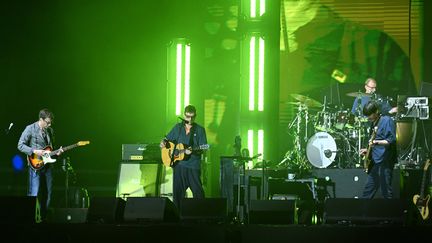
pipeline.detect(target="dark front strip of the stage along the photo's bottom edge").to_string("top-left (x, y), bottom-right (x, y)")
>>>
top-left (0, 222), bottom-right (432, 243)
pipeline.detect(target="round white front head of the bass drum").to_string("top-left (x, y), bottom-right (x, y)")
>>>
top-left (306, 132), bottom-right (337, 168)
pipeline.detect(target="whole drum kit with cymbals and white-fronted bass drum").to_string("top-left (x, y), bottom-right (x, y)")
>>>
top-left (283, 92), bottom-right (369, 168)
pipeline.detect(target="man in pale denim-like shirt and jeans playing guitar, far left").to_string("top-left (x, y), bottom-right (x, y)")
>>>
top-left (18, 109), bottom-right (63, 220)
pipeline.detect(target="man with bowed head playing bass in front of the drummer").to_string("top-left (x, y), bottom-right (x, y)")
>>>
top-left (360, 101), bottom-right (397, 199)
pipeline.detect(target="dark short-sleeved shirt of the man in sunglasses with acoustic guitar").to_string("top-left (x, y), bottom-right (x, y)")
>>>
top-left (166, 123), bottom-right (207, 169)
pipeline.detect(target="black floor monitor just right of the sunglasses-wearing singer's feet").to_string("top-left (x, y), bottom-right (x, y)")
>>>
top-left (180, 198), bottom-right (228, 223)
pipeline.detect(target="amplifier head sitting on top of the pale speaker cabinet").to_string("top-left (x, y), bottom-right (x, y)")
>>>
top-left (122, 143), bottom-right (160, 161)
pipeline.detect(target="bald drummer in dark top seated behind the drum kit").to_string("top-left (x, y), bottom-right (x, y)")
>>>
top-left (351, 78), bottom-right (397, 117)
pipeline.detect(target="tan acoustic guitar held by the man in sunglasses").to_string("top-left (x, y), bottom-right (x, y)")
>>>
top-left (161, 141), bottom-right (210, 167)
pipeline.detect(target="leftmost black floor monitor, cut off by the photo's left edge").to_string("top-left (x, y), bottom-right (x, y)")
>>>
top-left (0, 196), bottom-right (41, 224)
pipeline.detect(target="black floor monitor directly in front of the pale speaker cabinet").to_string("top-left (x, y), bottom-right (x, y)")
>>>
top-left (124, 197), bottom-right (179, 223)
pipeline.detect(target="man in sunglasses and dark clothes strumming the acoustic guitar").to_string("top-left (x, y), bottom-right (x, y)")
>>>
top-left (160, 105), bottom-right (207, 207)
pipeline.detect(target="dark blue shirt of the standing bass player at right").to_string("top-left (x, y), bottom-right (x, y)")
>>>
top-left (371, 116), bottom-right (396, 164)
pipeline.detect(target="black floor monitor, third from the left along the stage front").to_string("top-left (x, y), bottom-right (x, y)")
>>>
top-left (87, 197), bottom-right (126, 223)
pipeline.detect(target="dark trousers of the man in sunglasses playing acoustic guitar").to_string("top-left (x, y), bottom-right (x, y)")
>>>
top-left (173, 164), bottom-right (204, 208)
